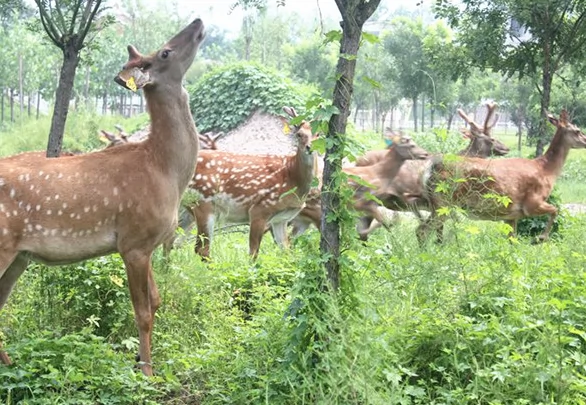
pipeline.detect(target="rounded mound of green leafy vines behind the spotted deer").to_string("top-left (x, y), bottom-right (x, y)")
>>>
top-left (189, 63), bottom-right (314, 132)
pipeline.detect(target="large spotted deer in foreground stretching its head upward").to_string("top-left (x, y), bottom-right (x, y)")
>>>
top-left (0, 19), bottom-right (204, 375)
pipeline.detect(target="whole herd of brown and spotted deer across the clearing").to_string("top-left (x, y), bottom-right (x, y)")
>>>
top-left (0, 19), bottom-right (586, 375)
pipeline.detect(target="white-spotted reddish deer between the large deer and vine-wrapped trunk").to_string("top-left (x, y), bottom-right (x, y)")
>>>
top-left (186, 107), bottom-right (317, 259)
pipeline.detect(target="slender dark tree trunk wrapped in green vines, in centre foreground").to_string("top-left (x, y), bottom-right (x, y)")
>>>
top-left (319, 0), bottom-right (380, 291)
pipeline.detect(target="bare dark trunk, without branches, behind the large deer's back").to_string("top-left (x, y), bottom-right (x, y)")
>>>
top-left (47, 43), bottom-right (79, 157)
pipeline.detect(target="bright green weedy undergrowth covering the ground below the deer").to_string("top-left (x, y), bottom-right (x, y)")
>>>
top-left (0, 213), bottom-right (586, 405)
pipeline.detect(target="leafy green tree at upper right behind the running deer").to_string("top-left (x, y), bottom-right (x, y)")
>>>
top-left (436, 0), bottom-right (586, 156)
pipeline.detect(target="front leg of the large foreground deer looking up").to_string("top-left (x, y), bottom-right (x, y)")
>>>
top-left (120, 249), bottom-right (155, 376)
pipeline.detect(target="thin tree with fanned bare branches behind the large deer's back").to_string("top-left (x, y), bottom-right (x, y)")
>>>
top-left (35, 0), bottom-right (111, 157)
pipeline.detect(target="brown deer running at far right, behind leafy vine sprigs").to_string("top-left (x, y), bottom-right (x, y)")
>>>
top-left (417, 110), bottom-right (586, 242)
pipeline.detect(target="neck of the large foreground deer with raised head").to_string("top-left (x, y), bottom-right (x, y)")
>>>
top-left (145, 86), bottom-right (199, 190)
